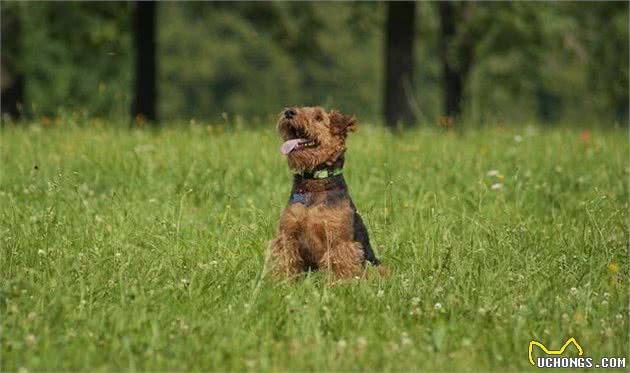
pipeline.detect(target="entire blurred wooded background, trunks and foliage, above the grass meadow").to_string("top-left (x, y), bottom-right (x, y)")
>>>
top-left (0, 1), bottom-right (629, 126)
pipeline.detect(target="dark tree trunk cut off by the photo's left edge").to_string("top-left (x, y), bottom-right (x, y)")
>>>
top-left (0, 4), bottom-right (24, 120)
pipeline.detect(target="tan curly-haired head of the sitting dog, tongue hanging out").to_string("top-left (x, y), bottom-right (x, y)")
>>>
top-left (277, 106), bottom-right (357, 171)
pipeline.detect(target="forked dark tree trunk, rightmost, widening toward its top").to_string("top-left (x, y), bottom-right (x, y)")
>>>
top-left (438, 1), bottom-right (474, 117)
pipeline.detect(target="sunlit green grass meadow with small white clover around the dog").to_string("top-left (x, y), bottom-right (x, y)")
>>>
top-left (0, 122), bottom-right (630, 371)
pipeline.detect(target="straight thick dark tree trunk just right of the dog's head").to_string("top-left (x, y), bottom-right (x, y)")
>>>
top-left (384, 2), bottom-right (416, 128)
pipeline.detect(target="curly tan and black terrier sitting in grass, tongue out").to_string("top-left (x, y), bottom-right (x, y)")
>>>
top-left (268, 107), bottom-right (383, 279)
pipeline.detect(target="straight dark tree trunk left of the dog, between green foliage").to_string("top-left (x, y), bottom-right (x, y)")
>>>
top-left (131, 1), bottom-right (157, 122)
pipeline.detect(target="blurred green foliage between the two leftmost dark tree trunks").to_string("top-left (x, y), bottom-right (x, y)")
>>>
top-left (17, 2), bottom-right (132, 117)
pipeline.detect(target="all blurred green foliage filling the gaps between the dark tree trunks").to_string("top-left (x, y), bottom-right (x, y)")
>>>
top-left (2, 2), bottom-right (629, 123)
